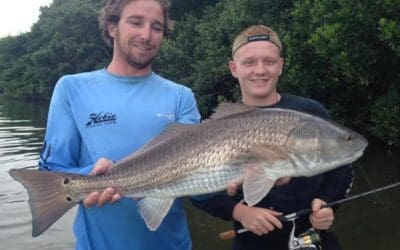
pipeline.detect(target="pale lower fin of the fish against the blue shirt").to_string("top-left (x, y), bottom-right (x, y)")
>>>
top-left (139, 198), bottom-right (174, 231)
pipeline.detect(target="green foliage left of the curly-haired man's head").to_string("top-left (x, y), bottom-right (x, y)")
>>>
top-left (0, 0), bottom-right (110, 100)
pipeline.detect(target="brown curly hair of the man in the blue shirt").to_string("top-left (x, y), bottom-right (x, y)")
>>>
top-left (99, 0), bottom-right (173, 47)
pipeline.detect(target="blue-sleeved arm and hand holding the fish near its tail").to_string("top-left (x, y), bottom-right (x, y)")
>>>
top-left (39, 79), bottom-right (121, 207)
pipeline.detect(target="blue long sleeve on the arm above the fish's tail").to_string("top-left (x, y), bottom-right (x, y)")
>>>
top-left (39, 78), bottom-right (93, 175)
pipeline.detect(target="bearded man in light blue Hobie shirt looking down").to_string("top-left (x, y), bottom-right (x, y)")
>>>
top-left (40, 0), bottom-right (200, 250)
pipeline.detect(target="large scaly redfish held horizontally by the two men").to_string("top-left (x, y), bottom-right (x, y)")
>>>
top-left (10, 103), bottom-right (367, 236)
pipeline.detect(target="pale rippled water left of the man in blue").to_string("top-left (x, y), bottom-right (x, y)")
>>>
top-left (0, 99), bottom-right (74, 249)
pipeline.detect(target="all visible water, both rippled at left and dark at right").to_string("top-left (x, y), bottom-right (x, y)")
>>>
top-left (0, 99), bottom-right (400, 250)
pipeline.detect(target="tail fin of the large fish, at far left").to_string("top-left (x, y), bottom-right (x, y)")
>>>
top-left (9, 169), bottom-right (78, 237)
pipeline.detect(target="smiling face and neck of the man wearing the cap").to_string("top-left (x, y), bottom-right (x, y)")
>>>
top-left (229, 41), bottom-right (283, 105)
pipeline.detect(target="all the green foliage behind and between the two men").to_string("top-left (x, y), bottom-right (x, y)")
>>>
top-left (0, 0), bottom-right (400, 146)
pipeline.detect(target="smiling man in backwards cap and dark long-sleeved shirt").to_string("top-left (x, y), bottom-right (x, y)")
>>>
top-left (193, 25), bottom-right (353, 250)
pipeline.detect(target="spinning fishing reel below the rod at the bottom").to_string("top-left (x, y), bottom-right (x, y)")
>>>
top-left (288, 220), bottom-right (321, 250)
